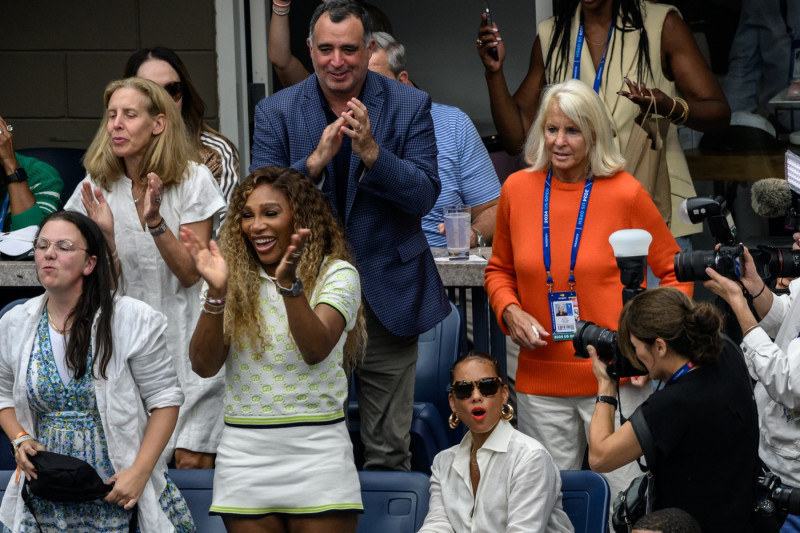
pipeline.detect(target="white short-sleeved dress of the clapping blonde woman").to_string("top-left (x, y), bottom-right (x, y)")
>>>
top-left (64, 162), bottom-right (225, 453)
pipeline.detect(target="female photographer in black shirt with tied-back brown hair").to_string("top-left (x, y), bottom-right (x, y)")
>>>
top-left (588, 288), bottom-right (758, 533)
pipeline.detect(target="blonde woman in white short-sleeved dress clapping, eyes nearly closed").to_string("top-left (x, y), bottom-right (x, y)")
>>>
top-left (65, 78), bottom-right (225, 468)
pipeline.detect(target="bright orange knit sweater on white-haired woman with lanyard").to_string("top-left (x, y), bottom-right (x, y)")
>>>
top-left (485, 170), bottom-right (693, 396)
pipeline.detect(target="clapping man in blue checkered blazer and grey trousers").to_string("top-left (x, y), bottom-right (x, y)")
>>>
top-left (250, 0), bottom-right (450, 470)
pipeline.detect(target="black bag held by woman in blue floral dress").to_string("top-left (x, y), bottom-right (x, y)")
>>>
top-left (22, 450), bottom-right (139, 533)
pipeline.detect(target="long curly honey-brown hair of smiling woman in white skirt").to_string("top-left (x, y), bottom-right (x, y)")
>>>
top-left (219, 167), bottom-right (366, 372)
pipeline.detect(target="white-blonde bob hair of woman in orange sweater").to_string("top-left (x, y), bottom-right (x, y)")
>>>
top-left (524, 80), bottom-right (625, 178)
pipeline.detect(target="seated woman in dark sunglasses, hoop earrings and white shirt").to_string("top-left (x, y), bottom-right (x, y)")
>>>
top-left (420, 352), bottom-right (573, 533)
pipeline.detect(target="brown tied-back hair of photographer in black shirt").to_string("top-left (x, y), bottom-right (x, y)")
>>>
top-left (617, 287), bottom-right (724, 370)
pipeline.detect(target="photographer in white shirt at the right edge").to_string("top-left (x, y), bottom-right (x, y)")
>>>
top-left (704, 233), bottom-right (800, 532)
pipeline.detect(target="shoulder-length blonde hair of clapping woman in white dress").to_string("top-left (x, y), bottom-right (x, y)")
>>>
top-left (83, 78), bottom-right (200, 191)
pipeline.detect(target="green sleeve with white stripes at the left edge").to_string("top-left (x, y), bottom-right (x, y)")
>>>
top-left (10, 154), bottom-right (64, 231)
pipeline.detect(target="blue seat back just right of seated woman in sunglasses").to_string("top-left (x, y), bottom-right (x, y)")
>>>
top-left (561, 470), bottom-right (611, 533)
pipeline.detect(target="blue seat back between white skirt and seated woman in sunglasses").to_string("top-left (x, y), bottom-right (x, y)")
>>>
top-left (358, 471), bottom-right (430, 533)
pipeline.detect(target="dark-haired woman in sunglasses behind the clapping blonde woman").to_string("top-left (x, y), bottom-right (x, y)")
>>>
top-left (124, 46), bottom-right (239, 203)
